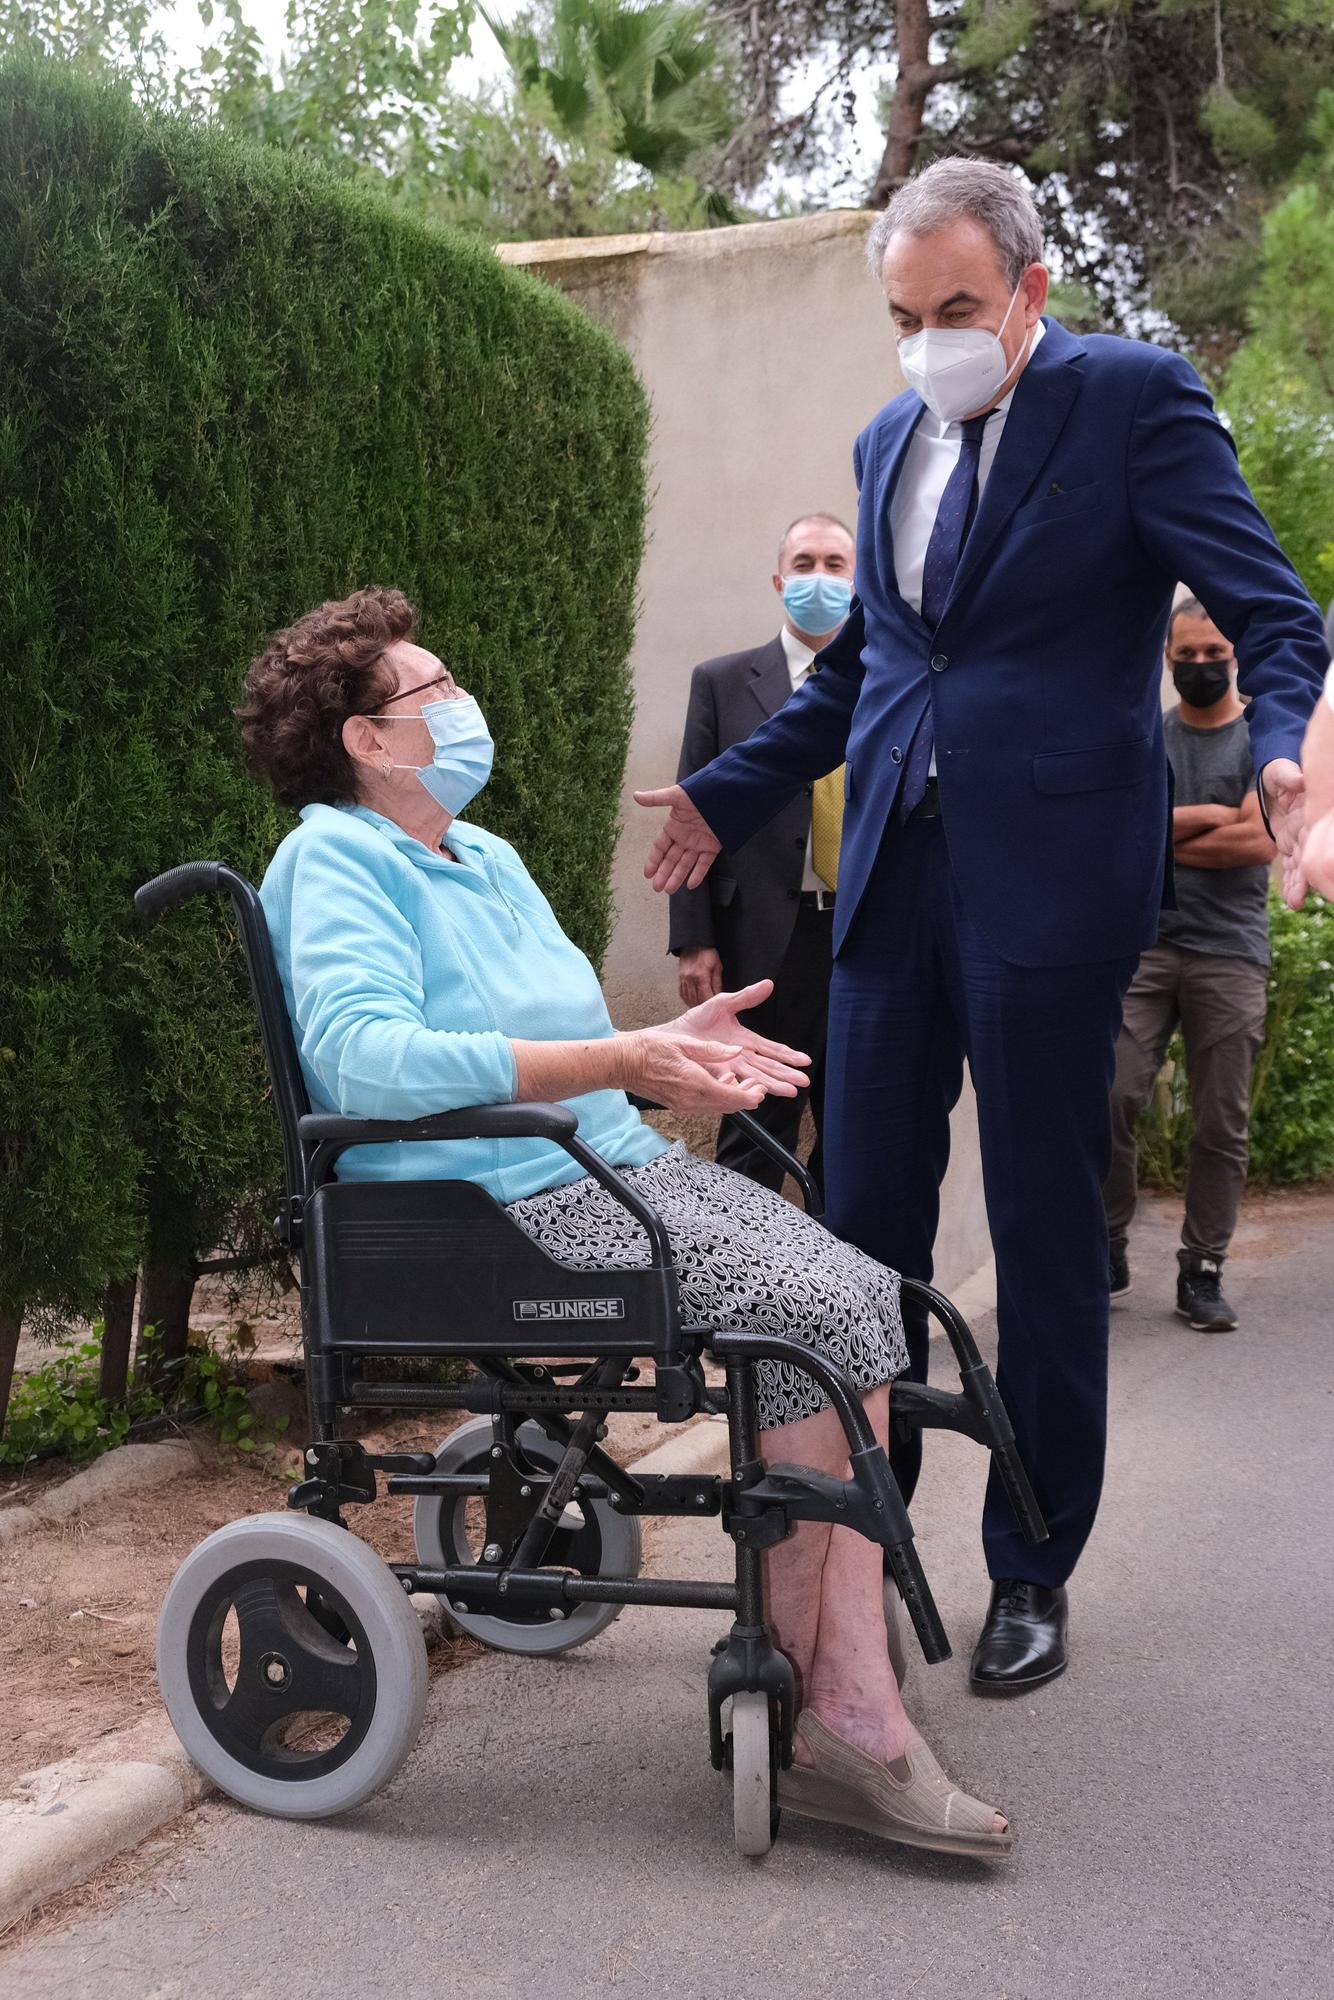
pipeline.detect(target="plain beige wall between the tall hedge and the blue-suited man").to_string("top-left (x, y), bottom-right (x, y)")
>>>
top-left (500, 212), bottom-right (990, 1302)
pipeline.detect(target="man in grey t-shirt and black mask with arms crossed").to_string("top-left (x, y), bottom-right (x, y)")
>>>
top-left (1104, 598), bottom-right (1274, 1334)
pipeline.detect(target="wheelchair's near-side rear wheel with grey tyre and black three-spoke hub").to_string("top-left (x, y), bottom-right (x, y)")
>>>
top-left (158, 1514), bottom-right (426, 1820)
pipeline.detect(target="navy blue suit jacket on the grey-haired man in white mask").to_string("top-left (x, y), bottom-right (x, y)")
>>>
top-left (686, 320), bottom-right (1326, 966)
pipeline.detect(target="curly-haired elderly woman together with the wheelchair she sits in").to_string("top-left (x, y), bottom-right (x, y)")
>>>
top-left (140, 590), bottom-right (1042, 1858)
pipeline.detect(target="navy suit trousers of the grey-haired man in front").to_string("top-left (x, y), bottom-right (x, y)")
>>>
top-left (824, 818), bottom-right (1134, 1584)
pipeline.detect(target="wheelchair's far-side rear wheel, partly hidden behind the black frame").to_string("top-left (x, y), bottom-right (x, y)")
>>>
top-left (412, 1416), bottom-right (642, 1654)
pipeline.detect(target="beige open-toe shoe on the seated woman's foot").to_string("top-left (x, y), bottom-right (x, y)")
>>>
top-left (778, 1708), bottom-right (1014, 1862)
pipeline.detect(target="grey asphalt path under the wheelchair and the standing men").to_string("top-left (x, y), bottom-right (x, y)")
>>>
top-left (0, 1196), bottom-right (1334, 2000)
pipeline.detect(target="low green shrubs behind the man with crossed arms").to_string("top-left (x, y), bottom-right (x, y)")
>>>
top-left (1138, 890), bottom-right (1334, 1188)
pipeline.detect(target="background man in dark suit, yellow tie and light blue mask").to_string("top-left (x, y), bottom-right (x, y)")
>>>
top-left (668, 514), bottom-right (852, 1190)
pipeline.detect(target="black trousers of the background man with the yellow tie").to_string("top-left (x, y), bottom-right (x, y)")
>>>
top-left (714, 910), bottom-right (834, 1192)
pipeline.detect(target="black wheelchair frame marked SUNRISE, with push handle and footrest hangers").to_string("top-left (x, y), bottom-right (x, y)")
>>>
top-left (134, 862), bottom-right (1046, 1766)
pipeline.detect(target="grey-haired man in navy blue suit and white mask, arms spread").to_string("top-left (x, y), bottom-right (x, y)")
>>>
top-left (638, 160), bottom-right (1326, 1694)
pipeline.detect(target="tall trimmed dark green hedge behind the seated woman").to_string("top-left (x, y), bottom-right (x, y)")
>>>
top-left (0, 60), bottom-right (646, 1376)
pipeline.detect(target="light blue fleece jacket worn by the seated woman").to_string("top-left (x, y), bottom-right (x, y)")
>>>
top-left (260, 806), bottom-right (666, 1202)
